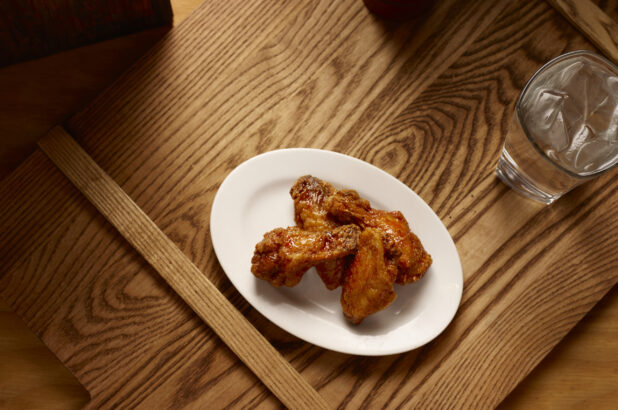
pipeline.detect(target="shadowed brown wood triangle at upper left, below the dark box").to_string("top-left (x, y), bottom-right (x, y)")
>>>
top-left (0, 28), bottom-right (169, 180)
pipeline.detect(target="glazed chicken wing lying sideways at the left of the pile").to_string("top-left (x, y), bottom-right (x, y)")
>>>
top-left (251, 225), bottom-right (360, 286)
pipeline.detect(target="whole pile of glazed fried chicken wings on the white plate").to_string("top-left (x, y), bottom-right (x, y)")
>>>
top-left (251, 175), bottom-right (432, 324)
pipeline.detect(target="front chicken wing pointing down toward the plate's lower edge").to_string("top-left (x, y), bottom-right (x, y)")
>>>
top-left (341, 228), bottom-right (397, 324)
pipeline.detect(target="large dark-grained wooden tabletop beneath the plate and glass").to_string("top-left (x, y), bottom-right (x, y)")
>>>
top-left (0, 1), bottom-right (617, 407)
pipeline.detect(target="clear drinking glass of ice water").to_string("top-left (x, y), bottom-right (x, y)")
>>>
top-left (496, 51), bottom-right (618, 204)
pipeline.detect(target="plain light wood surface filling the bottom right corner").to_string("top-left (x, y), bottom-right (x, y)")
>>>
top-left (500, 286), bottom-right (618, 410)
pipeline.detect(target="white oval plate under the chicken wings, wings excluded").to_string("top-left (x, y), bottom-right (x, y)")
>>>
top-left (210, 148), bottom-right (463, 356)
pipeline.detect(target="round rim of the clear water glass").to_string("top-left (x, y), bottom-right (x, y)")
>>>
top-left (515, 50), bottom-right (618, 179)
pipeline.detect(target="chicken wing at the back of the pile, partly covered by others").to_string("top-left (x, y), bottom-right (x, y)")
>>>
top-left (290, 175), bottom-right (350, 290)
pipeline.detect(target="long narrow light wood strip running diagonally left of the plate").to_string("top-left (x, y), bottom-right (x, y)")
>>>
top-left (39, 127), bottom-right (328, 409)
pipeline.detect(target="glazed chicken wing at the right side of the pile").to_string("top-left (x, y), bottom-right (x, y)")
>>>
top-left (324, 190), bottom-right (432, 284)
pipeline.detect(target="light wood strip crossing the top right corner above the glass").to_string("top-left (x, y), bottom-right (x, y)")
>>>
top-left (548, 0), bottom-right (618, 65)
